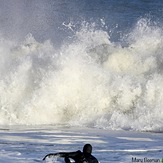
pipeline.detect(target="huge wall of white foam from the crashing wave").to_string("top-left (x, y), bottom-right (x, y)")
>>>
top-left (0, 19), bottom-right (163, 132)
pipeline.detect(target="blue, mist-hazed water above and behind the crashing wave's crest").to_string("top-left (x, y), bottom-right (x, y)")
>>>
top-left (0, 0), bottom-right (163, 45)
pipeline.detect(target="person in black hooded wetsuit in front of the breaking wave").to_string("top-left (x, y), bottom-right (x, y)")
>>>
top-left (43, 144), bottom-right (99, 163)
